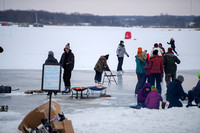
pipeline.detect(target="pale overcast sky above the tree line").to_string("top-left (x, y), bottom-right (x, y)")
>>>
top-left (0, 0), bottom-right (200, 16)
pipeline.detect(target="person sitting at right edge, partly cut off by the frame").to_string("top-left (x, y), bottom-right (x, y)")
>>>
top-left (186, 73), bottom-right (200, 108)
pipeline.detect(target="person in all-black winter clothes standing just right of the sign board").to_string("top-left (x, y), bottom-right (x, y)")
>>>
top-left (60, 43), bottom-right (74, 93)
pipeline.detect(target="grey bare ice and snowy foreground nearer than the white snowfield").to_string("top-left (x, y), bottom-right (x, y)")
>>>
top-left (0, 70), bottom-right (200, 133)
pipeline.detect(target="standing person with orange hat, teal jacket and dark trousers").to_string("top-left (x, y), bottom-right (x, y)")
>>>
top-left (135, 47), bottom-right (147, 94)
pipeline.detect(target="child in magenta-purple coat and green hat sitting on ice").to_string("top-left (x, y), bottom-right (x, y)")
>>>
top-left (145, 86), bottom-right (163, 109)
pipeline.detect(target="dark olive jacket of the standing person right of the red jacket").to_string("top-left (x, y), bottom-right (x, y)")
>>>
top-left (163, 52), bottom-right (181, 74)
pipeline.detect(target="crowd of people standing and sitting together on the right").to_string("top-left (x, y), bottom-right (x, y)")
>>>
top-left (135, 38), bottom-right (200, 109)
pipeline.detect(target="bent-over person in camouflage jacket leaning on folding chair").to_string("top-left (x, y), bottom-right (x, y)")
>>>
top-left (94, 54), bottom-right (110, 84)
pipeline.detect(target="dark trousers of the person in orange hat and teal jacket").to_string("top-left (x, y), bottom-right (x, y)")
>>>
top-left (135, 73), bottom-right (145, 94)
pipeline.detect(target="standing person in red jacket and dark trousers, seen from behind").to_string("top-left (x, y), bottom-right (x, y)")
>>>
top-left (145, 50), bottom-right (163, 94)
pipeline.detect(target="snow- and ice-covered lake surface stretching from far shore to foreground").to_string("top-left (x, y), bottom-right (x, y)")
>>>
top-left (0, 26), bottom-right (200, 133)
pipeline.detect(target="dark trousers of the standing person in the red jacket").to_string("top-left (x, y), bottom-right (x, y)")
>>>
top-left (150, 73), bottom-right (162, 94)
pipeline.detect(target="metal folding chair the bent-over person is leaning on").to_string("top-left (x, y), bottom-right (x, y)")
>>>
top-left (102, 70), bottom-right (117, 84)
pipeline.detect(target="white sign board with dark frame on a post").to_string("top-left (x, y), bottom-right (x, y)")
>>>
top-left (42, 64), bottom-right (61, 91)
